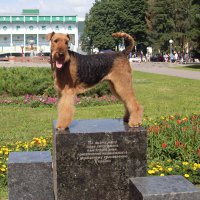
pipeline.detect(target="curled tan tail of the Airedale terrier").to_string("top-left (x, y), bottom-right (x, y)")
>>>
top-left (112, 32), bottom-right (135, 56)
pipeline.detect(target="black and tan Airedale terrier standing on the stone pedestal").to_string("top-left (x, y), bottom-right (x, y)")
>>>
top-left (47, 32), bottom-right (142, 130)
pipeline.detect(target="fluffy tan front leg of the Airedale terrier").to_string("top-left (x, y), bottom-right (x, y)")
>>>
top-left (56, 91), bottom-right (74, 130)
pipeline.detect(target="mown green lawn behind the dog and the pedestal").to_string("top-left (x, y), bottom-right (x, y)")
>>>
top-left (0, 72), bottom-right (200, 200)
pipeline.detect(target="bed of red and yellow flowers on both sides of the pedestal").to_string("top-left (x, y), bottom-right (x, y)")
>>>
top-left (0, 114), bottom-right (200, 184)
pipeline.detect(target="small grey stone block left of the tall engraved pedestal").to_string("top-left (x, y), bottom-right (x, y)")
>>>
top-left (8, 151), bottom-right (54, 200)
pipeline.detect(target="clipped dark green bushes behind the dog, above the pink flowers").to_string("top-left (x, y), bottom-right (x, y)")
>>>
top-left (0, 67), bottom-right (110, 96)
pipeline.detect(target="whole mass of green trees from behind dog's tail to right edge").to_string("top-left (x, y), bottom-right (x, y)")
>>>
top-left (82, 0), bottom-right (200, 55)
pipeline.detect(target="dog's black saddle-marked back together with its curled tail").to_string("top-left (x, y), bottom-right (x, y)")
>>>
top-left (69, 32), bottom-right (134, 85)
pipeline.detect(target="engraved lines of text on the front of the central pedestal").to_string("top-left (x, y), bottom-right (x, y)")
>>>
top-left (78, 140), bottom-right (128, 163)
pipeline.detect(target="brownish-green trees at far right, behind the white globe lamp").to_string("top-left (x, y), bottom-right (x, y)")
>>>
top-left (146, 0), bottom-right (200, 52)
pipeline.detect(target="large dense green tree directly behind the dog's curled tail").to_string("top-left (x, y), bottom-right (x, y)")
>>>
top-left (82, 0), bottom-right (147, 50)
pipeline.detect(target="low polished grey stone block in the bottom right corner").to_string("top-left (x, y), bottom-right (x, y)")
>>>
top-left (130, 175), bottom-right (200, 200)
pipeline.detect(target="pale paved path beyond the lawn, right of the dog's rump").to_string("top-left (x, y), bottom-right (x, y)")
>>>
top-left (131, 62), bottom-right (200, 80)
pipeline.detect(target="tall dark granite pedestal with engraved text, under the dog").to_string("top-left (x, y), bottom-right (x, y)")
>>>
top-left (53, 119), bottom-right (147, 200)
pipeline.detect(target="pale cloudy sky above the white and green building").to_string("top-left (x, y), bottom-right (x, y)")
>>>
top-left (0, 0), bottom-right (95, 18)
